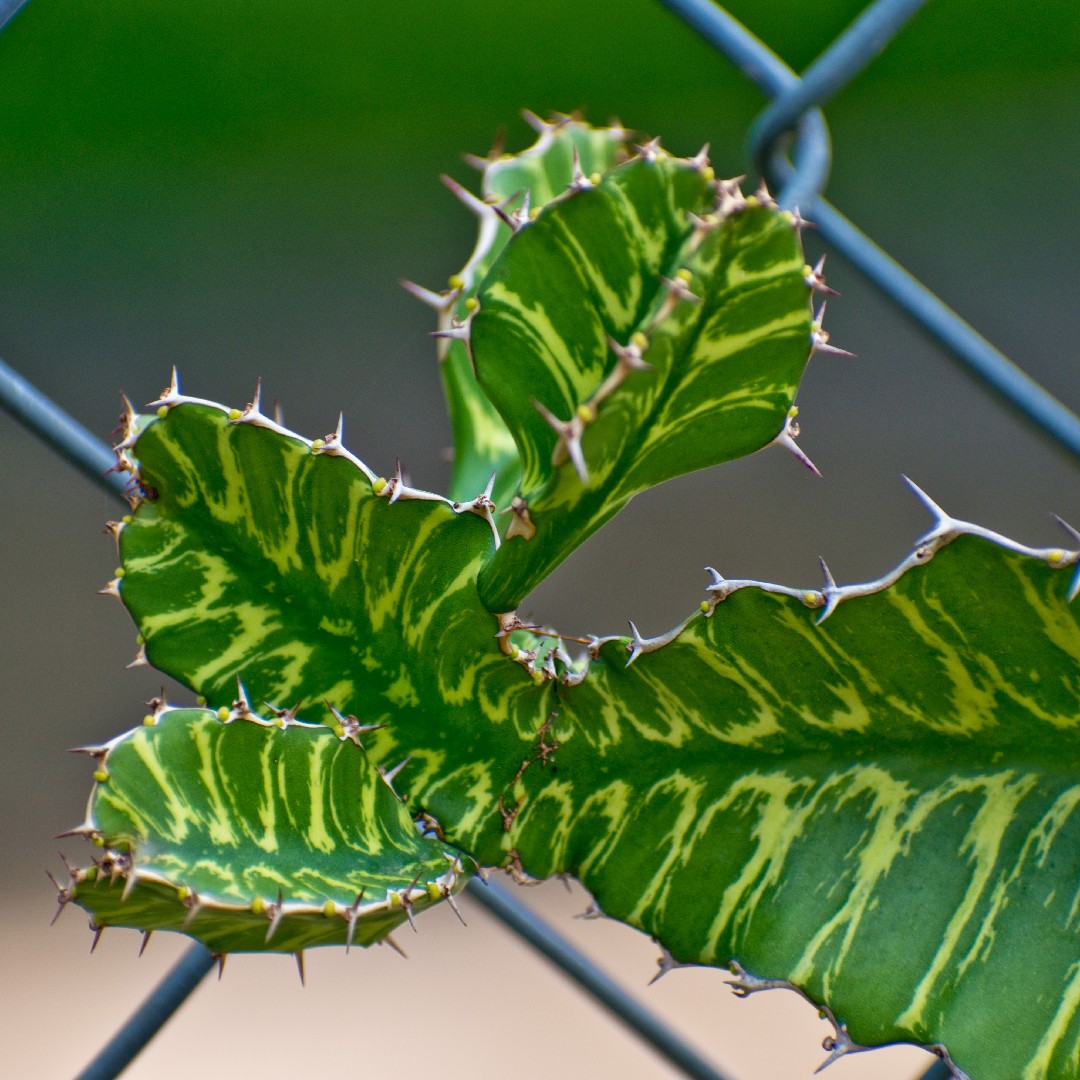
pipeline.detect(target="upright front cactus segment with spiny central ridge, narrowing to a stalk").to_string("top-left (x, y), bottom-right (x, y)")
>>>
top-left (470, 151), bottom-right (823, 611)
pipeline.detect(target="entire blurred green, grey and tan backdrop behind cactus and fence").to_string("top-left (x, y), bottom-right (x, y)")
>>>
top-left (0, 0), bottom-right (1080, 1080)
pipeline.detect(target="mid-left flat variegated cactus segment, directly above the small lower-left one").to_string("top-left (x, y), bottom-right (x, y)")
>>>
top-left (107, 388), bottom-right (554, 863)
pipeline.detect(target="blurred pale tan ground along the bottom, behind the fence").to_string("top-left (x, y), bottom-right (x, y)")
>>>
top-left (6, 875), bottom-right (931, 1080)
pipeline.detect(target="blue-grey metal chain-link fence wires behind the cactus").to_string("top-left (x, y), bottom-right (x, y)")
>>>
top-left (0, 0), bottom-right (1080, 1080)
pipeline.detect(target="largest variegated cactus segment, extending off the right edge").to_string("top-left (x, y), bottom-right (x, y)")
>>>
top-left (505, 531), bottom-right (1080, 1080)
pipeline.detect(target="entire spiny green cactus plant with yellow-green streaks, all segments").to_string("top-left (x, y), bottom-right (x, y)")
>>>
top-left (60, 113), bottom-right (1080, 1080)
